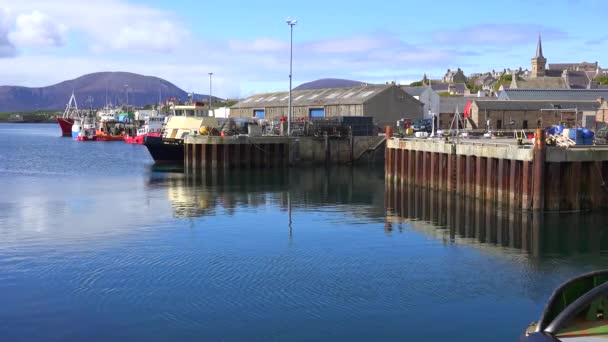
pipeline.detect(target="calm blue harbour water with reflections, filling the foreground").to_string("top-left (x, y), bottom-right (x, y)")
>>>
top-left (0, 124), bottom-right (608, 341)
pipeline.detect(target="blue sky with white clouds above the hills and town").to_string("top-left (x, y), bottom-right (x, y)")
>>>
top-left (0, 0), bottom-right (608, 98)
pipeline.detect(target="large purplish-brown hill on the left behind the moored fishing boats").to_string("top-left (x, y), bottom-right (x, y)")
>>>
top-left (0, 72), bottom-right (221, 113)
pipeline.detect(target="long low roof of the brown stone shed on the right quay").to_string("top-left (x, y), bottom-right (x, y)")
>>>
top-left (475, 100), bottom-right (600, 111)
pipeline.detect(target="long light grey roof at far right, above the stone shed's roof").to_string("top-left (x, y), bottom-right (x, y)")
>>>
top-left (498, 89), bottom-right (608, 101)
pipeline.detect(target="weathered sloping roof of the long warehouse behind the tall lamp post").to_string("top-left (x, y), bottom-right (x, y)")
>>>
top-left (231, 84), bottom-right (396, 108)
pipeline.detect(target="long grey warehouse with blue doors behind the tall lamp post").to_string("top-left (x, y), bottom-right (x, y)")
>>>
top-left (230, 84), bottom-right (424, 126)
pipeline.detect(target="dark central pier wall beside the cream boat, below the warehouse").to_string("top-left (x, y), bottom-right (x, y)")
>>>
top-left (184, 135), bottom-right (385, 172)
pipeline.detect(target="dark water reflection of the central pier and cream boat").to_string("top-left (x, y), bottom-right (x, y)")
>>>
top-left (157, 167), bottom-right (384, 218)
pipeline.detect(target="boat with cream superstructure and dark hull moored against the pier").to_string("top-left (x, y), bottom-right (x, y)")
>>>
top-left (144, 102), bottom-right (218, 164)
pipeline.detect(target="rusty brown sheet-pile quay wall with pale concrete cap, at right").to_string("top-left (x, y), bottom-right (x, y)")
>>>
top-left (385, 132), bottom-right (608, 211)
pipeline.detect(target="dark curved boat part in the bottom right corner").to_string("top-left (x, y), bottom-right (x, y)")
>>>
top-left (521, 270), bottom-right (608, 342)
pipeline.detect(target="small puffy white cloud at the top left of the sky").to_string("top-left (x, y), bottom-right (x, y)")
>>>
top-left (8, 11), bottom-right (66, 47)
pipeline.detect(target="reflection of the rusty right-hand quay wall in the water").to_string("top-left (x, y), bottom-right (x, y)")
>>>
top-left (385, 184), bottom-right (608, 257)
